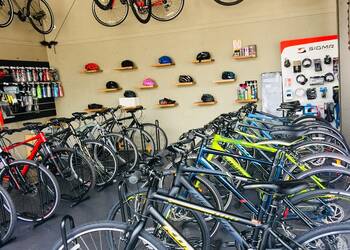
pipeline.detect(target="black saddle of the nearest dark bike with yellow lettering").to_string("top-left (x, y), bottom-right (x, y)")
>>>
top-left (243, 180), bottom-right (310, 196)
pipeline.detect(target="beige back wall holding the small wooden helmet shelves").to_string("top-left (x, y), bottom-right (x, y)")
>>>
top-left (43, 0), bottom-right (337, 140)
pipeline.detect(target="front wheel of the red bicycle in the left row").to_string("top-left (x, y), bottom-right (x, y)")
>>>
top-left (42, 148), bottom-right (96, 201)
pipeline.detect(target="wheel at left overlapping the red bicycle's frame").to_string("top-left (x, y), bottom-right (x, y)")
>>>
top-left (0, 160), bottom-right (61, 222)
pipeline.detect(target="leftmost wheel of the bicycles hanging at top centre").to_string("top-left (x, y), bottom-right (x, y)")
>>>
top-left (92, 0), bottom-right (129, 27)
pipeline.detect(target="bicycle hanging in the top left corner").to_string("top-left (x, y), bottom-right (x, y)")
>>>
top-left (0, 0), bottom-right (54, 35)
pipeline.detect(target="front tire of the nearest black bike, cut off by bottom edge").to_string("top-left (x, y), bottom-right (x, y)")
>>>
top-left (53, 221), bottom-right (166, 250)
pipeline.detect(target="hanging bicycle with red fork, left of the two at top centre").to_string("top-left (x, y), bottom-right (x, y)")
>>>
top-left (92, 0), bottom-right (152, 27)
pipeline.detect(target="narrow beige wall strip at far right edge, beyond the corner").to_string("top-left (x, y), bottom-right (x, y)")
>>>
top-left (338, 0), bottom-right (350, 139)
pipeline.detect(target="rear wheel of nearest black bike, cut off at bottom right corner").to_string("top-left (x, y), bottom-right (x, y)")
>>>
top-left (295, 223), bottom-right (350, 250)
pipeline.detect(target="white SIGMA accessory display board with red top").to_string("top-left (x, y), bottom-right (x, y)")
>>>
top-left (281, 35), bottom-right (339, 125)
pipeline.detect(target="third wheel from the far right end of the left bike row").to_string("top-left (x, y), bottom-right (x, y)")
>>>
top-left (100, 133), bottom-right (139, 171)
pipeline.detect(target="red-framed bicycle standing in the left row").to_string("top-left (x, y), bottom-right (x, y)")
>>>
top-left (5, 123), bottom-right (96, 204)
